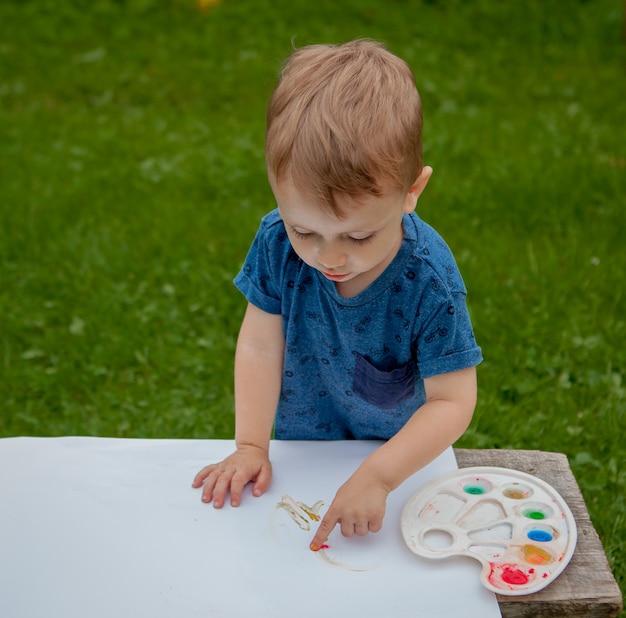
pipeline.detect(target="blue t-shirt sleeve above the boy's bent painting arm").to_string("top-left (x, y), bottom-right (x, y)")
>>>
top-left (417, 291), bottom-right (483, 379)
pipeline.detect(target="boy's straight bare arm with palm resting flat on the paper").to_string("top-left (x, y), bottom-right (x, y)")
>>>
top-left (193, 303), bottom-right (285, 508)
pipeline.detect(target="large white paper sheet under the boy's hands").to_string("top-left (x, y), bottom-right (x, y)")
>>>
top-left (0, 438), bottom-right (500, 618)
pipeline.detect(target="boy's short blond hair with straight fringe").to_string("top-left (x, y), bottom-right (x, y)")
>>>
top-left (265, 39), bottom-right (423, 214)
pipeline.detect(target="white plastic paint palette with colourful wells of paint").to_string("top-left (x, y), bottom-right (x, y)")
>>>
top-left (401, 467), bottom-right (577, 595)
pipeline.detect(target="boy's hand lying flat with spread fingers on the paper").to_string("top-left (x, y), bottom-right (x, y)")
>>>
top-left (192, 445), bottom-right (272, 509)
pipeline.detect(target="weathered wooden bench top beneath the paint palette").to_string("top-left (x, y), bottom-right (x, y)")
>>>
top-left (455, 449), bottom-right (622, 618)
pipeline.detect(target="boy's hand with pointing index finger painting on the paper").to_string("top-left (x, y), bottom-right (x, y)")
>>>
top-left (310, 470), bottom-right (389, 551)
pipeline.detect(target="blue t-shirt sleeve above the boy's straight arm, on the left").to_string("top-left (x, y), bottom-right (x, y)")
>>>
top-left (234, 216), bottom-right (283, 314)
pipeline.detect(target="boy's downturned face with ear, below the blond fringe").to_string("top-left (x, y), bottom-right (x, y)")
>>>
top-left (270, 168), bottom-right (432, 296)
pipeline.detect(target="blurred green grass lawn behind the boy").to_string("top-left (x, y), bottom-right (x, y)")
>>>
top-left (0, 0), bottom-right (626, 608)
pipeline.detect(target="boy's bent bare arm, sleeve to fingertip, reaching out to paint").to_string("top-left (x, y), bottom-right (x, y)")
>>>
top-left (311, 367), bottom-right (477, 551)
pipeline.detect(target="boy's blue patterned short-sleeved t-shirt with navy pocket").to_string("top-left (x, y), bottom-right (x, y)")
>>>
top-left (235, 210), bottom-right (482, 440)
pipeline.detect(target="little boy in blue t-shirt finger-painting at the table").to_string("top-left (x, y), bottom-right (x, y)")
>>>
top-left (193, 40), bottom-right (482, 551)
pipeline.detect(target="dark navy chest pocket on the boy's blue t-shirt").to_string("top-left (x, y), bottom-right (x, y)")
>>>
top-left (352, 354), bottom-right (415, 410)
